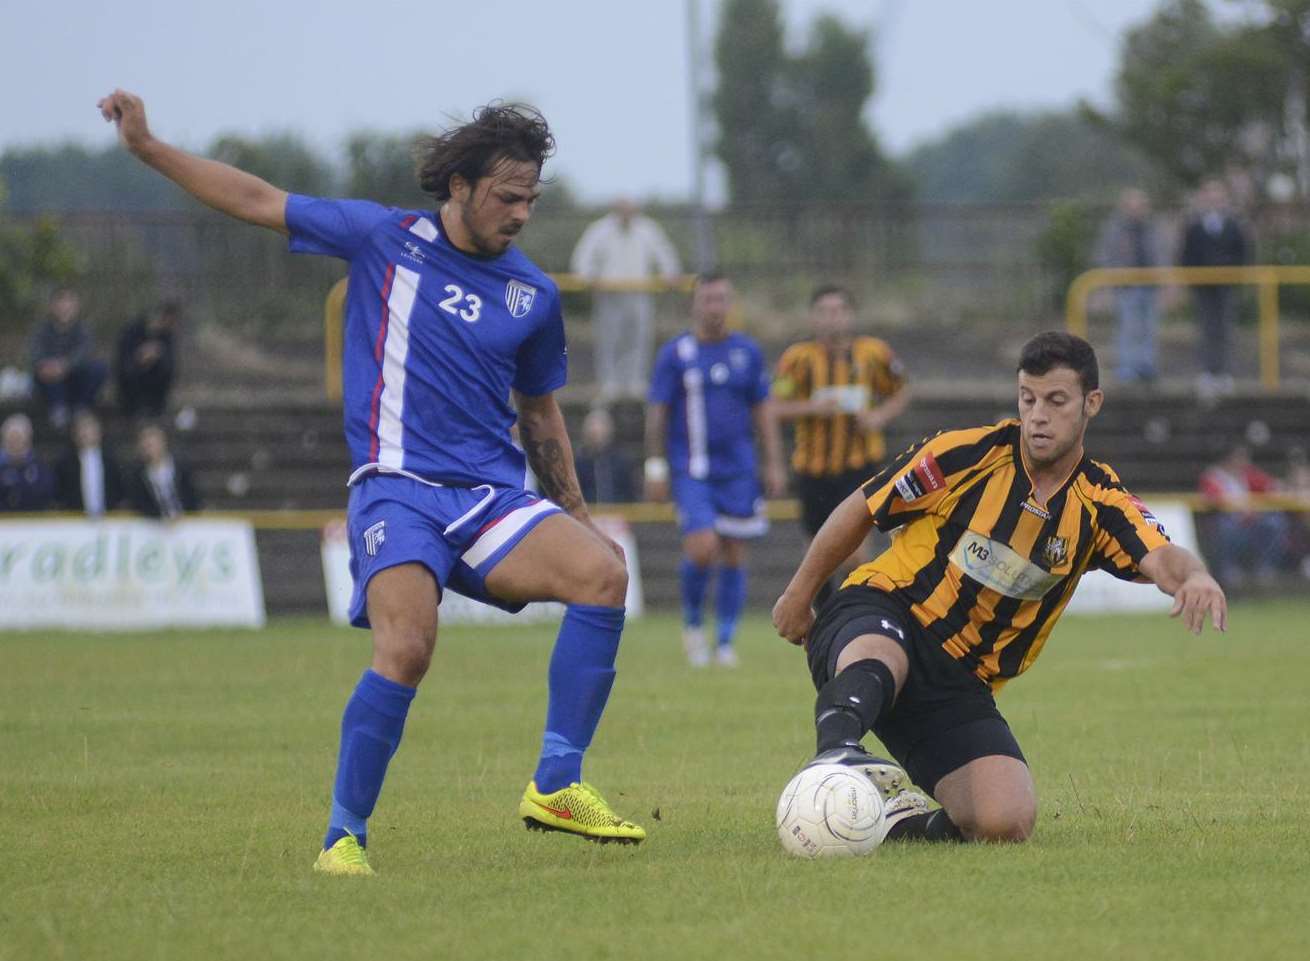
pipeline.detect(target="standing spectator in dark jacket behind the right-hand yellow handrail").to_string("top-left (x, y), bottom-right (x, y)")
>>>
top-left (1178, 178), bottom-right (1250, 397)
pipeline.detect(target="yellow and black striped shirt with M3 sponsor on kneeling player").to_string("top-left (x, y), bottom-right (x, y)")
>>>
top-left (844, 420), bottom-right (1169, 690)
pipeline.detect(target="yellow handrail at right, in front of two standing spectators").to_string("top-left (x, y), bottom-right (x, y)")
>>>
top-left (1065, 264), bottom-right (1310, 390)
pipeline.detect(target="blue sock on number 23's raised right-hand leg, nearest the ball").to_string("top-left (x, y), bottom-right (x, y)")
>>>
top-left (533, 604), bottom-right (624, 795)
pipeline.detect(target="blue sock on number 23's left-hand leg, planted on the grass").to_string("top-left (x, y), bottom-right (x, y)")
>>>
top-left (324, 670), bottom-right (414, 850)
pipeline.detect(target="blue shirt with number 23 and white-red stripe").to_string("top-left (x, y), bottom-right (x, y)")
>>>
top-left (287, 194), bottom-right (567, 487)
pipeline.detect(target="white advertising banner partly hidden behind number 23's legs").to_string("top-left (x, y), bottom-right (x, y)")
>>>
top-left (322, 516), bottom-right (643, 625)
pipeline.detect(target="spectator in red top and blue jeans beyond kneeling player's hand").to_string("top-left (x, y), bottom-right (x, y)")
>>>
top-left (1200, 444), bottom-right (1289, 585)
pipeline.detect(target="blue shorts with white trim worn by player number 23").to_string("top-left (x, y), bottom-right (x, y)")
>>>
top-left (346, 474), bottom-right (561, 627)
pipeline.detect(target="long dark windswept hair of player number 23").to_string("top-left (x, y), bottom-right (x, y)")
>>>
top-left (415, 103), bottom-right (555, 202)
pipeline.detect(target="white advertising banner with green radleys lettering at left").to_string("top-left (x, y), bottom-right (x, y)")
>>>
top-left (0, 518), bottom-right (265, 631)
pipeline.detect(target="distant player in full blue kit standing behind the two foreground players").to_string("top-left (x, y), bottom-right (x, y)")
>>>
top-left (646, 274), bottom-right (786, 666)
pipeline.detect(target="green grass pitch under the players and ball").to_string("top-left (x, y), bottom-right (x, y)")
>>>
top-left (0, 602), bottom-right (1310, 961)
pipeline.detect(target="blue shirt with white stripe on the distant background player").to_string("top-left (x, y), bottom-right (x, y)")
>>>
top-left (650, 331), bottom-right (769, 481)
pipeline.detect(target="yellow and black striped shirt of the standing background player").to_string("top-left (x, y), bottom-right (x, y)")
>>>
top-left (773, 336), bottom-right (905, 477)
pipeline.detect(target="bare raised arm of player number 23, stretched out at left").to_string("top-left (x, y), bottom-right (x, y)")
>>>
top-left (96, 90), bottom-right (287, 233)
